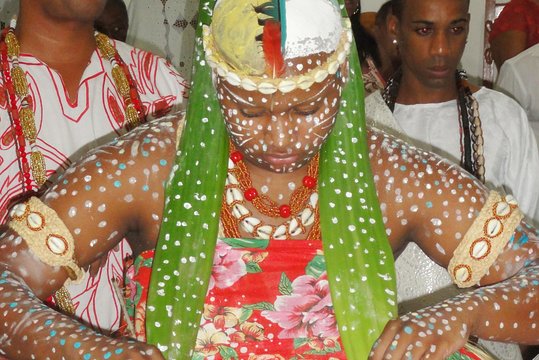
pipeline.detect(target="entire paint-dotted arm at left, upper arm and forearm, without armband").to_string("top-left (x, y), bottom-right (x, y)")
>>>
top-left (0, 117), bottom-right (181, 359)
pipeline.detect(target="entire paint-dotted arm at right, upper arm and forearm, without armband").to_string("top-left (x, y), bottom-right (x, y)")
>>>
top-left (371, 130), bottom-right (539, 359)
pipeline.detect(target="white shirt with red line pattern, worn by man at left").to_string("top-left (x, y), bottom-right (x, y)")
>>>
top-left (0, 41), bottom-right (187, 330)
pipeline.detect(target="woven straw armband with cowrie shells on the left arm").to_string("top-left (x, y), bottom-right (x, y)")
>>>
top-left (8, 197), bottom-right (84, 282)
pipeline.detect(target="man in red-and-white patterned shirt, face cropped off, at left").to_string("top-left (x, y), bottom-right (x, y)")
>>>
top-left (0, 0), bottom-right (187, 330)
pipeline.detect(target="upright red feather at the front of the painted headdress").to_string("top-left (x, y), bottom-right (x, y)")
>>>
top-left (255, 0), bottom-right (286, 78)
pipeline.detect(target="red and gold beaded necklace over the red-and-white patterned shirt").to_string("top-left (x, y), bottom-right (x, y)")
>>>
top-left (0, 24), bottom-right (145, 191)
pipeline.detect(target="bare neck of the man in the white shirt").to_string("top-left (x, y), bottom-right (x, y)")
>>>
top-left (396, 74), bottom-right (458, 105)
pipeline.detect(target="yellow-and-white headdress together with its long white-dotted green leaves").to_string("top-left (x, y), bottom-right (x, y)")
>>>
top-left (146, 0), bottom-right (397, 360)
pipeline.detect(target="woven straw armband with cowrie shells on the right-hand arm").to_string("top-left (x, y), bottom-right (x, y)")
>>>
top-left (448, 191), bottom-right (523, 288)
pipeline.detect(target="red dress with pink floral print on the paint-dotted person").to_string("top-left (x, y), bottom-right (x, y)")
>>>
top-left (126, 239), bottom-right (346, 360)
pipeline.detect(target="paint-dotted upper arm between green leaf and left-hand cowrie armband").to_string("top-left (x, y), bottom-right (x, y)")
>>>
top-left (44, 117), bottom-right (183, 263)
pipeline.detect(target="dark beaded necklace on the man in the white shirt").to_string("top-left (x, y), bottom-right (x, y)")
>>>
top-left (382, 69), bottom-right (485, 183)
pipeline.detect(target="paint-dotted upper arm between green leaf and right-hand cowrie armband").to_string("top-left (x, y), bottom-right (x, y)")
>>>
top-left (368, 125), bottom-right (487, 264)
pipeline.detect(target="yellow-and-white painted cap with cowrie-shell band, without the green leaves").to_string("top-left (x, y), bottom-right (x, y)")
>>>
top-left (204, 0), bottom-right (352, 94)
